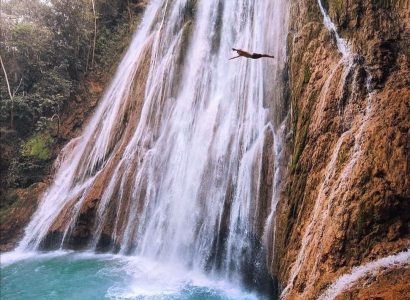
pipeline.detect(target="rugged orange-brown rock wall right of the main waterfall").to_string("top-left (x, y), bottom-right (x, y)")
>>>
top-left (272, 0), bottom-right (410, 299)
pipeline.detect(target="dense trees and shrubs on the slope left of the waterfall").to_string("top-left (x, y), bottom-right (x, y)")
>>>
top-left (0, 0), bottom-right (142, 209)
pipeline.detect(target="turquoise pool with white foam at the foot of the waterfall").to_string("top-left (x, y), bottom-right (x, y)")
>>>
top-left (0, 251), bottom-right (259, 300)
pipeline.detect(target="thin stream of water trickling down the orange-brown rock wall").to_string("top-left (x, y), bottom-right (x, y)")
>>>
top-left (280, 0), bottom-right (372, 299)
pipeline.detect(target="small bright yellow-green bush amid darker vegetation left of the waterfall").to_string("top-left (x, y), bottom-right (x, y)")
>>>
top-left (22, 134), bottom-right (53, 160)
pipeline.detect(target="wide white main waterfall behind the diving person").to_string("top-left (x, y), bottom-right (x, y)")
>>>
top-left (18, 0), bottom-right (288, 290)
